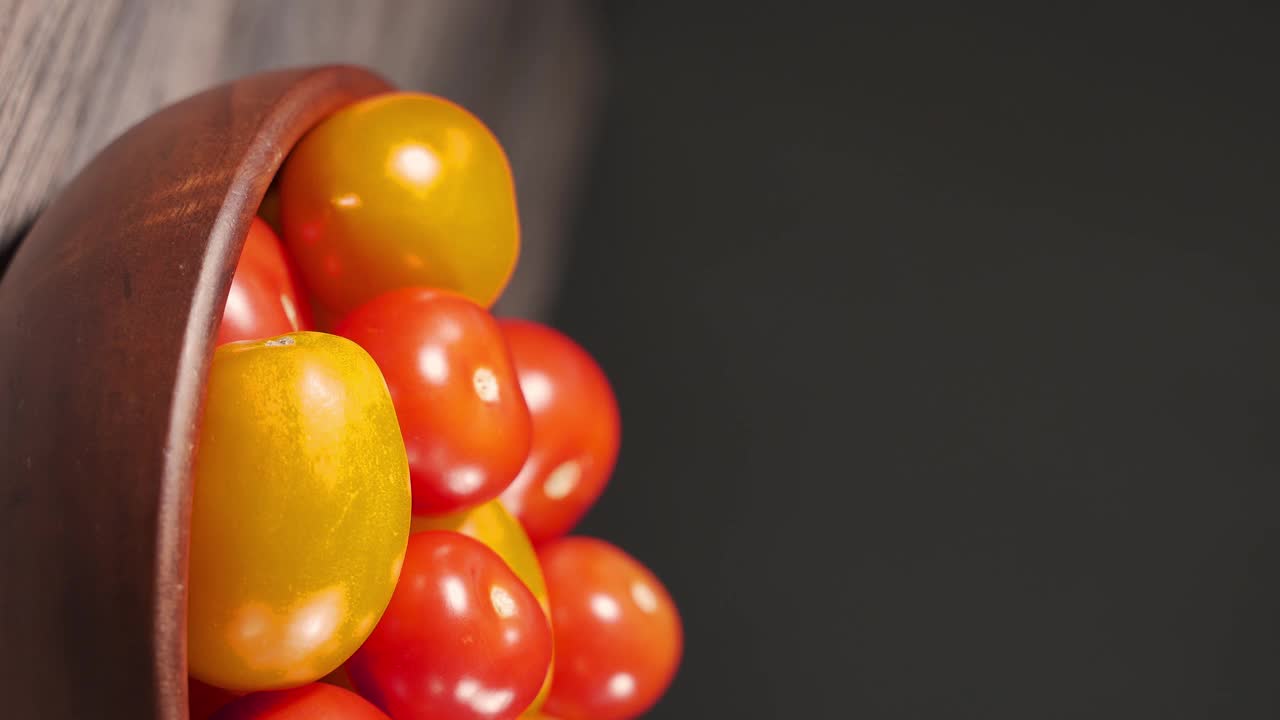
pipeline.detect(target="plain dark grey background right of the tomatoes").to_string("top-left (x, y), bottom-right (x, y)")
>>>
top-left (556, 1), bottom-right (1280, 719)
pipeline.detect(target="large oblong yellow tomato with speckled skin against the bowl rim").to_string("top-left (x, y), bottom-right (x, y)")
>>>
top-left (187, 332), bottom-right (411, 691)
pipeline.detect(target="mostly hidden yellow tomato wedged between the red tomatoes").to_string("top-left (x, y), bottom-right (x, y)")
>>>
top-left (410, 500), bottom-right (554, 710)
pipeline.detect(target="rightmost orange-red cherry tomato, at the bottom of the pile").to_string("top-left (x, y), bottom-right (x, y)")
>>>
top-left (538, 537), bottom-right (684, 720)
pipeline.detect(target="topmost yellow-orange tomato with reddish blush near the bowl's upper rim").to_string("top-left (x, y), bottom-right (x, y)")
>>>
top-left (280, 92), bottom-right (520, 315)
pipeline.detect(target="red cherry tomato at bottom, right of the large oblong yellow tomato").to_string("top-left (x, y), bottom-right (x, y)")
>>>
top-left (347, 530), bottom-right (552, 720)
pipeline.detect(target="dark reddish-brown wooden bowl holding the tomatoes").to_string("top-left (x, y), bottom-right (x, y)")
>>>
top-left (0, 67), bottom-right (390, 720)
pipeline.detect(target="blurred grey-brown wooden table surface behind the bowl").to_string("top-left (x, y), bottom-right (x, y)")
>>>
top-left (0, 0), bottom-right (603, 316)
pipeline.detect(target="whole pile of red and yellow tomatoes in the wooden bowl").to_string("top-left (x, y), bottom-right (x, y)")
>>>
top-left (187, 94), bottom-right (682, 720)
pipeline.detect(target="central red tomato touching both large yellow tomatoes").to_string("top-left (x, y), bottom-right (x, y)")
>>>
top-left (334, 288), bottom-right (530, 515)
